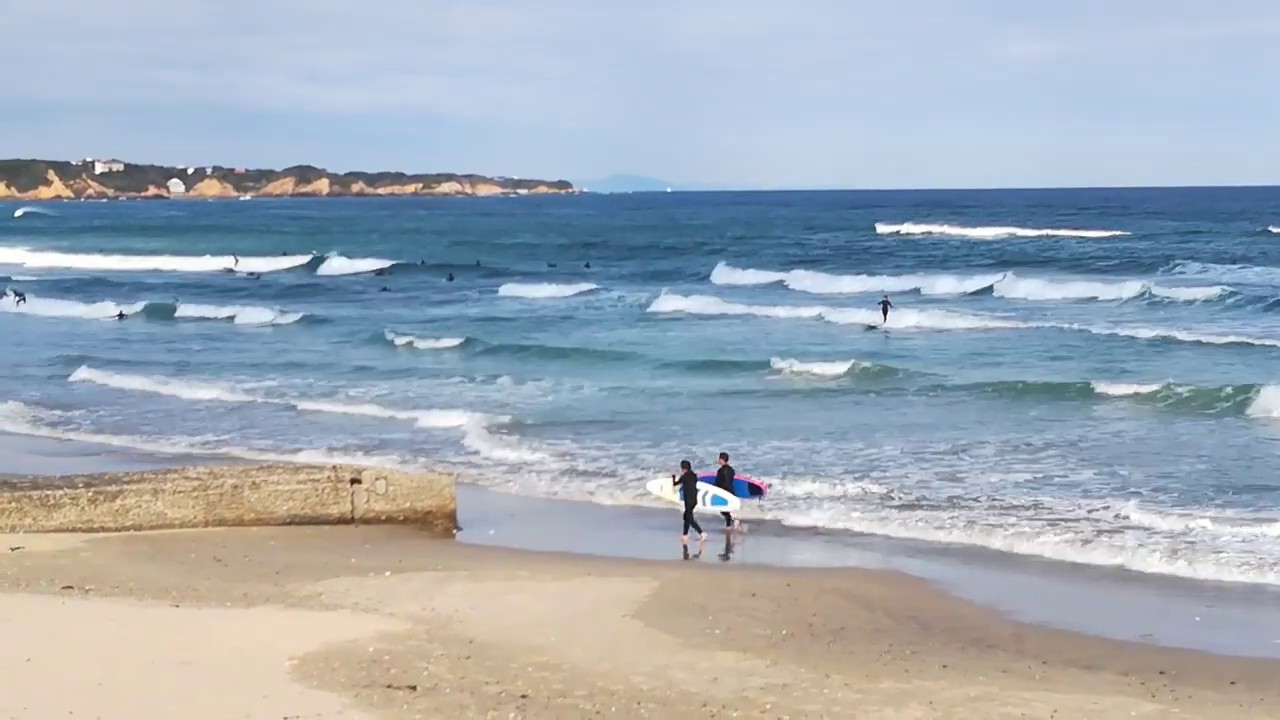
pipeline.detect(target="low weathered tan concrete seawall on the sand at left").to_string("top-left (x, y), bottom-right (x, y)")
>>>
top-left (0, 464), bottom-right (457, 536)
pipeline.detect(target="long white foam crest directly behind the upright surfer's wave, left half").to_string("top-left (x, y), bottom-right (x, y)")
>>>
top-left (710, 261), bottom-right (1005, 295)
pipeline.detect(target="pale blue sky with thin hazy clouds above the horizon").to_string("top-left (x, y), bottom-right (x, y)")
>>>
top-left (0, 0), bottom-right (1280, 188)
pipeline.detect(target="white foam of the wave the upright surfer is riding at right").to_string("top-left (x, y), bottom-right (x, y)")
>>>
top-left (648, 291), bottom-right (1029, 331)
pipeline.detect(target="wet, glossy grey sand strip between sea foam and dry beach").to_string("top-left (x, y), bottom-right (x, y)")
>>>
top-left (0, 433), bottom-right (1280, 659)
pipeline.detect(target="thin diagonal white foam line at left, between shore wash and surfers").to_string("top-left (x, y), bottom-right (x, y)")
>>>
top-left (67, 365), bottom-right (494, 429)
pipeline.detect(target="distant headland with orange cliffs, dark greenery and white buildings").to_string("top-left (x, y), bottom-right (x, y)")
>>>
top-left (0, 158), bottom-right (575, 200)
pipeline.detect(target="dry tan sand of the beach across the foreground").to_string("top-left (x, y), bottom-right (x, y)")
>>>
top-left (0, 527), bottom-right (1280, 720)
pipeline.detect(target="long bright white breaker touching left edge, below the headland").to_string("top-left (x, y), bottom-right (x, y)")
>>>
top-left (0, 247), bottom-right (312, 273)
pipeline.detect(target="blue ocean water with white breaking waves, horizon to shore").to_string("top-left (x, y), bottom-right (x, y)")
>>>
top-left (0, 188), bottom-right (1280, 585)
